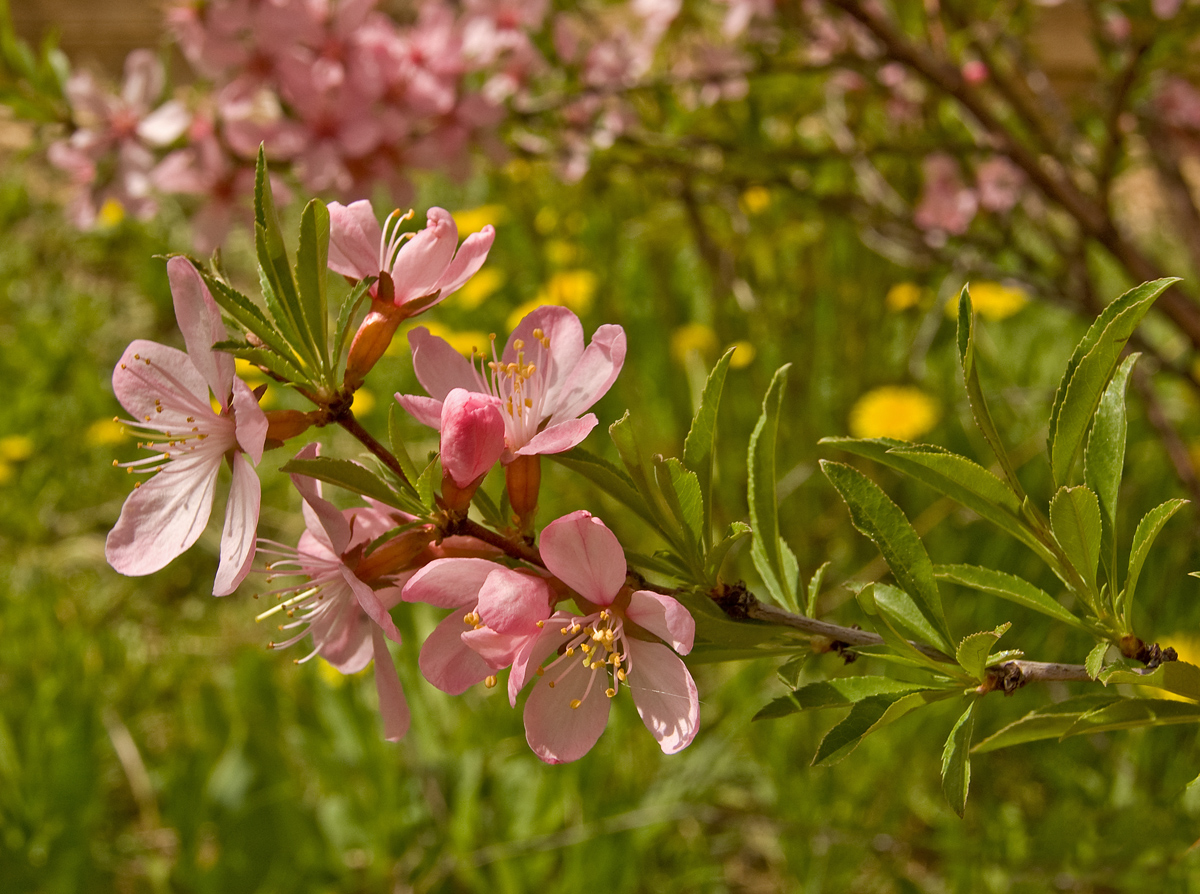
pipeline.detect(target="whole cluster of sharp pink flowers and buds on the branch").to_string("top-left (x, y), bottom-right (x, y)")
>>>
top-left (108, 202), bottom-right (700, 763)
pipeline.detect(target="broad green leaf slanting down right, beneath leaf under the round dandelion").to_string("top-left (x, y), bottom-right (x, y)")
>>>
top-left (821, 460), bottom-right (950, 649)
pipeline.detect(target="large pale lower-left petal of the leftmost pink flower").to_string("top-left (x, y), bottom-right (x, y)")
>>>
top-left (104, 453), bottom-right (221, 576)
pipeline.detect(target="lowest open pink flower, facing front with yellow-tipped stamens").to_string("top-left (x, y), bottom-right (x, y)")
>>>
top-left (524, 510), bottom-right (700, 763)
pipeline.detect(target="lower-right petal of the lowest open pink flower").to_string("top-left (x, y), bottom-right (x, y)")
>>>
top-left (628, 640), bottom-right (700, 755)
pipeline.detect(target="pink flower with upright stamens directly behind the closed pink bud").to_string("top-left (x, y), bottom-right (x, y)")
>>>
top-left (396, 305), bottom-right (625, 463)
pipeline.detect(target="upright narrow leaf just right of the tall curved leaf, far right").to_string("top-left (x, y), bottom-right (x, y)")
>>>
top-left (1084, 354), bottom-right (1141, 593)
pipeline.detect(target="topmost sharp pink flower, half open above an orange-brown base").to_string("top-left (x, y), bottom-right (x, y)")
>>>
top-left (329, 199), bottom-right (496, 317)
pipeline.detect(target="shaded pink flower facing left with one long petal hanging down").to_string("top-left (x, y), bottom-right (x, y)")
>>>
top-left (258, 444), bottom-right (428, 742)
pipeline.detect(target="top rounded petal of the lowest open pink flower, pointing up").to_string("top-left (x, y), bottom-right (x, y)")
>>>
top-left (541, 509), bottom-right (628, 606)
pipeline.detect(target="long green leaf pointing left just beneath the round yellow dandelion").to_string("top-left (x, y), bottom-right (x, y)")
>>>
top-left (820, 438), bottom-right (1054, 563)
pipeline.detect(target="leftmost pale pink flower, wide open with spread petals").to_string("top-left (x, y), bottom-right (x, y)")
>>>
top-left (104, 258), bottom-right (266, 596)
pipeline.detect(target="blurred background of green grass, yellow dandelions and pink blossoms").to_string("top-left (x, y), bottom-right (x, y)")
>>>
top-left (7, 0), bottom-right (1200, 894)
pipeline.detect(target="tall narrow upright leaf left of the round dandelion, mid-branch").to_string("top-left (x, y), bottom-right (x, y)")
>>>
top-left (748, 364), bottom-right (800, 612)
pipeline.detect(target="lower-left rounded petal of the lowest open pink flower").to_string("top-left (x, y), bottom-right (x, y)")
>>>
top-left (524, 656), bottom-right (610, 763)
